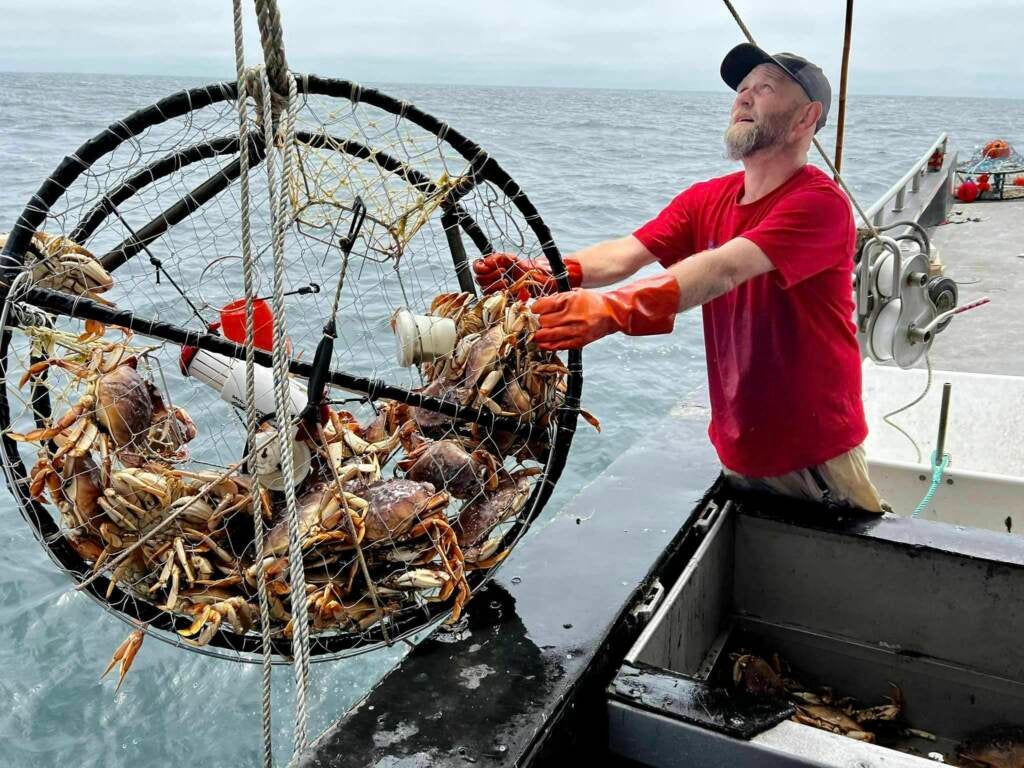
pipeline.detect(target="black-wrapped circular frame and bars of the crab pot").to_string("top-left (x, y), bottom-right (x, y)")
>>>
top-left (0, 75), bottom-right (583, 660)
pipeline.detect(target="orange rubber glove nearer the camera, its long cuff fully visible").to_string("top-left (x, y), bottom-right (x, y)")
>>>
top-left (530, 273), bottom-right (679, 350)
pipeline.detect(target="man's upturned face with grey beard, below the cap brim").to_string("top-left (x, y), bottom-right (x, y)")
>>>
top-left (725, 65), bottom-right (809, 160)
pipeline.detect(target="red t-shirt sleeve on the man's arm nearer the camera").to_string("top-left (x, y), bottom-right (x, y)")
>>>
top-left (740, 188), bottom-right (857, 288)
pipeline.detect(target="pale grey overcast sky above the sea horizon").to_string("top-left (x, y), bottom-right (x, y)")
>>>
top-left (0, 0), bottom-right (1024, 98)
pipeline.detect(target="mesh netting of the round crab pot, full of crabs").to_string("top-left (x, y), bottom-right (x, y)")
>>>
top-left (0, 77), bottom-right (581, 659)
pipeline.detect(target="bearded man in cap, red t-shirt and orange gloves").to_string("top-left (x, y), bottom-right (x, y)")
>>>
top-left (474, 44), bottom-right (882, 512)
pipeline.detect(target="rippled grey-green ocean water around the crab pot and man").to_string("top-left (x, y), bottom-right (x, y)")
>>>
top-left (0, 69), bottom-right (1024, 767)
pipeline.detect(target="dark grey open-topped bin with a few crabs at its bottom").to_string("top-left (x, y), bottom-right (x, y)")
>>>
top-left (608, 497), bottom-right (1024, 768)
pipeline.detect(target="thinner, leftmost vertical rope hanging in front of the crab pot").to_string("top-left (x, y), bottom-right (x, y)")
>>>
top-left (233, 0), bottom-right (273, 768)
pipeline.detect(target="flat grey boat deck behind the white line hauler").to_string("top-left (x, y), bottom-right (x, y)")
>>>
top-left (921, 200), bottom-right (1024, 376)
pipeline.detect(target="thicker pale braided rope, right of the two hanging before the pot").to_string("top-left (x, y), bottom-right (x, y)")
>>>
top-left (260, 71), bottom-right (309, 756)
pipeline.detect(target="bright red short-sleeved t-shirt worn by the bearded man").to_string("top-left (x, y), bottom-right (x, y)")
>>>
top-left (634, 165), bottom-right (867, 477)
